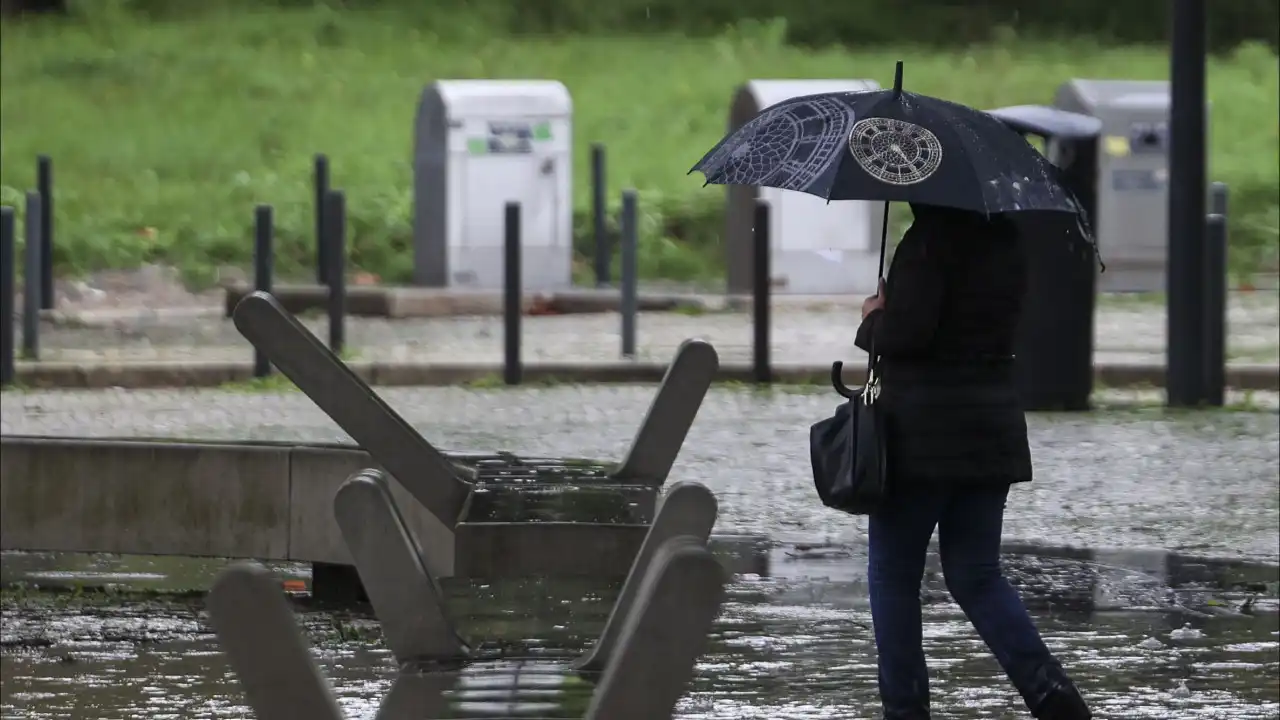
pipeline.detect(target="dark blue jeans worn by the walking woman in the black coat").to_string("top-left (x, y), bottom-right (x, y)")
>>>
top-left (868, 486), bottom-right (1053, 716)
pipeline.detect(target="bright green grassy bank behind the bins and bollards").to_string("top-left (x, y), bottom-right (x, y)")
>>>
top-left (0, 8), bottom-right (1280, 281)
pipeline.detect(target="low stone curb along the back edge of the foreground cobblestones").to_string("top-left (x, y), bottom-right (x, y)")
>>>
top-left (17, 360), bottom-right (1280, 392)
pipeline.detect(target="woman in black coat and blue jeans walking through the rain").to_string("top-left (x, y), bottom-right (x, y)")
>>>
top-left (856, 205), bottom-right (1092, 720)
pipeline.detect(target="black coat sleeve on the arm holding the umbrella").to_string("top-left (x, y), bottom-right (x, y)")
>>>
top-left (854, 231), bottom-right (943, 357)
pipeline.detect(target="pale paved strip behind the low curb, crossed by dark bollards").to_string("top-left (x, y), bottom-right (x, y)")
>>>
top-left (17, 292), bottom-right (1280, 365)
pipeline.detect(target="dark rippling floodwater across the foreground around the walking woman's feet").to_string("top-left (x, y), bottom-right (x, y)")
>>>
top-left (0, 552), bottom-right (1280, 720)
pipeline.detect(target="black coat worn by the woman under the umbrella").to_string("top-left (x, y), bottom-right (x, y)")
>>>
top-left (856, 211), bottom-right (1032, 484)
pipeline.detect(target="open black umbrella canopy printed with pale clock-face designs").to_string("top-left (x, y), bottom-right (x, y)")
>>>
top-left (690, 63), bottom-right (1082, 214)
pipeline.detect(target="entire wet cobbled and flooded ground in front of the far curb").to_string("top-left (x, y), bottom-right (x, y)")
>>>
top-left (0, 386), bottom-right (1280, 720)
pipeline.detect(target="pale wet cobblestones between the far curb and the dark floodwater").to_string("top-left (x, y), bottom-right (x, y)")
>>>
top-left (0, 386), bottom-right (1280, 562)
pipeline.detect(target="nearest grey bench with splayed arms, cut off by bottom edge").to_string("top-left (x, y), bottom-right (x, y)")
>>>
top-left (209, 486), bottom-right (724, 720)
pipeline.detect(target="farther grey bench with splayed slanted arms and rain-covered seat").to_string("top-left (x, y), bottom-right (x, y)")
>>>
top-left (233, 292), bottom-right (719, 577)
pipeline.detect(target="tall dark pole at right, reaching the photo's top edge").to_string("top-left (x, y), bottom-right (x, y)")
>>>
top-left (1166, 0), bottom-right (1207, 407)
